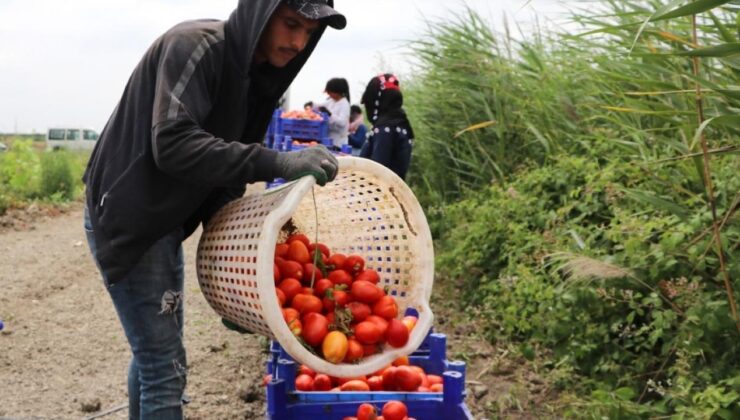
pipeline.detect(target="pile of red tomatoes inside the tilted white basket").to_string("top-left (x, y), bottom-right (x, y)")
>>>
top-left (273, 233), bottom-right (417, 363)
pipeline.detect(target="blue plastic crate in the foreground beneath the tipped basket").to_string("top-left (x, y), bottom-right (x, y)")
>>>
top-left (267, 333), bottom-right (473, 420)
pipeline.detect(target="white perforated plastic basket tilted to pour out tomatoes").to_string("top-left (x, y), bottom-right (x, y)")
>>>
top-left (197, 157), bottom-right (434, 378)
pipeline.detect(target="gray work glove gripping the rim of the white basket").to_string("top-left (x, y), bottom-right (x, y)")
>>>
top-left (275, 145), bottom-right (339, 186)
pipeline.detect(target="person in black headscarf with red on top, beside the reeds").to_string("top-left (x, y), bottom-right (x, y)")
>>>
top-left (360, 73), bottom-right (414, 179)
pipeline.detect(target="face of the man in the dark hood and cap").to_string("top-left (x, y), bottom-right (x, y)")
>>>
top-left (254, 4), bottom-right (320, 67)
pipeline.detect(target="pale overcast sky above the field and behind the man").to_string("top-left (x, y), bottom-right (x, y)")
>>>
top-left (0, 0), bottom-right (564, 133)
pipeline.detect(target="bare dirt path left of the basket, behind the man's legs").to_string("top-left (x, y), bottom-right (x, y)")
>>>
top-left (0, 205), bottom-right (266, 419)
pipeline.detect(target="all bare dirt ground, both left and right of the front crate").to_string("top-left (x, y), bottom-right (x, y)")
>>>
top-left (0, 203), bottom-right (548, 419)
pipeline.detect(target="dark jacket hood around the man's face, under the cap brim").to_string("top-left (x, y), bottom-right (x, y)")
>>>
top-left (225, 0), bottom-right (334, 79)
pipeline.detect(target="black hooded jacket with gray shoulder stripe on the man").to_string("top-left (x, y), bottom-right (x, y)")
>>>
top-left (83, 0), bottom-right (333, 284)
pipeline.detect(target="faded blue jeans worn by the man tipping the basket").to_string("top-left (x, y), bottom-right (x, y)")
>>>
top-left (85, 208), bottom-right (187, 420)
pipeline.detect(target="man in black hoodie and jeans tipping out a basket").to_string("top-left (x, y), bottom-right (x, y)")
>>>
top-left (83, 0), bottom-right (346, 419)
